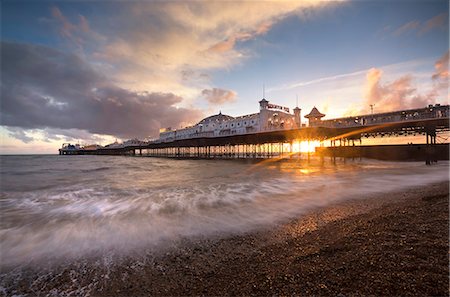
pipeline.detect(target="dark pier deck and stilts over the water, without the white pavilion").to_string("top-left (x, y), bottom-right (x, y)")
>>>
top-left (59, 105), bottom-right (449, 164)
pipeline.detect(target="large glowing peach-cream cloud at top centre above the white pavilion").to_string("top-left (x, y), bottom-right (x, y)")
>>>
top-left (94, 1), bottom-right (336, 96)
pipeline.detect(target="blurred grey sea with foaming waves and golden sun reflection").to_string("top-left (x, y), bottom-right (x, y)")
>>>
top-left (0, 155), bottom-right (449, 296)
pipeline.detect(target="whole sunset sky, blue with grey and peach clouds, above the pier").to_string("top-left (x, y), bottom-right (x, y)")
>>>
top-left (0, 0), bottom-right (449, 154)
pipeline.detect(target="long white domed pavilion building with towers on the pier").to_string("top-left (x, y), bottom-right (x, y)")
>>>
top-left (157, 98), bottom-right (301, 142)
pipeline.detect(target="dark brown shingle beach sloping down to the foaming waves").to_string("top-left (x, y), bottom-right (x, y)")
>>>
top-left (2, 182), bottom-right (449, 296)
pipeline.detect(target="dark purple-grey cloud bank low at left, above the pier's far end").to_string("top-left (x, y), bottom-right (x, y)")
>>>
top-left (0, 42), bottom-right (202, 141)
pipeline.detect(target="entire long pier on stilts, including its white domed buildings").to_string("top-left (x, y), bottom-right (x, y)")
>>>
top-left (59, 98), bottom-right (449, 164)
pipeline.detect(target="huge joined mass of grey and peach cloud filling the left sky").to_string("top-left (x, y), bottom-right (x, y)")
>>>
top-left (0, 1), bottom-right (338, 145)
